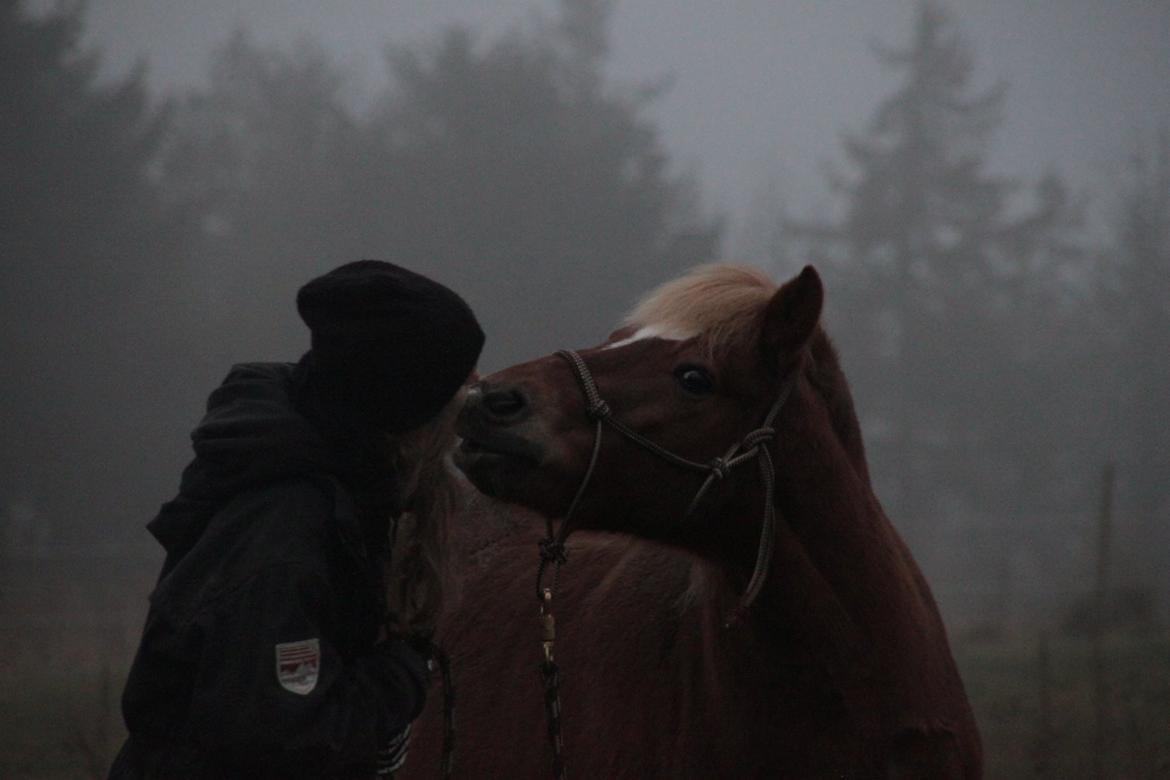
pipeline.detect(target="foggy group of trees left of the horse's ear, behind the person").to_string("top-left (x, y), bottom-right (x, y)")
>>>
top-left (0, 0), bottom-right (720, 549)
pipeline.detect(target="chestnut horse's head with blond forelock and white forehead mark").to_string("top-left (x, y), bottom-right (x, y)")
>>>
top-left (456, 265), bottom-right (824, 557)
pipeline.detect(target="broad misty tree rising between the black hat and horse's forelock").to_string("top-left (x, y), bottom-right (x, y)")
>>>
top-left (365, 0), bottom-right (718, 361)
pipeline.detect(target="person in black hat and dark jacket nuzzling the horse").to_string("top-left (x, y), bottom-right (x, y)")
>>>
top-left (110, 261), bottom-right (483, 780)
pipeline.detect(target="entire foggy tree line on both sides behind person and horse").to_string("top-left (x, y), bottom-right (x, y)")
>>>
top-left (0, 0), bottom-right (1170, 608)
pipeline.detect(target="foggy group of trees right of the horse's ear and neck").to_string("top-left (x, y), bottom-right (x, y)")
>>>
top-left (757, 0), bottom-right (1170, 608)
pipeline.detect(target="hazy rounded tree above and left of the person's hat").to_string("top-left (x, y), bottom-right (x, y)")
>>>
top-left (163, 32), bottom-right (367, 362)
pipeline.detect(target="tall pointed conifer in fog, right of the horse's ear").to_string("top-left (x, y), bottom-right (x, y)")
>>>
top-left (786, 0), bottom-right (1076, 558)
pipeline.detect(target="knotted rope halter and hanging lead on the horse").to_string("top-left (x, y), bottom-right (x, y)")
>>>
top-left (536, 350), bottom-right (796, 780)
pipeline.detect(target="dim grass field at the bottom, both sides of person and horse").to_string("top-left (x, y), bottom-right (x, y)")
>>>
top-left (0, 635), bottom-right (1170, 780)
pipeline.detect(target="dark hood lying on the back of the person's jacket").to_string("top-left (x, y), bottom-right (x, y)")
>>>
top-left (147, 363), bottom-right (342, 554)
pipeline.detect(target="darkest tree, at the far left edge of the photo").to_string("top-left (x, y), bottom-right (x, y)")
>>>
top-left (0, 0), bottom-right (198, 547)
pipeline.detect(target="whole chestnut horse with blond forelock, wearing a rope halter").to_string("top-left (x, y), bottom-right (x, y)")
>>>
top-left (407, 265), bottom-right (982, 779)
